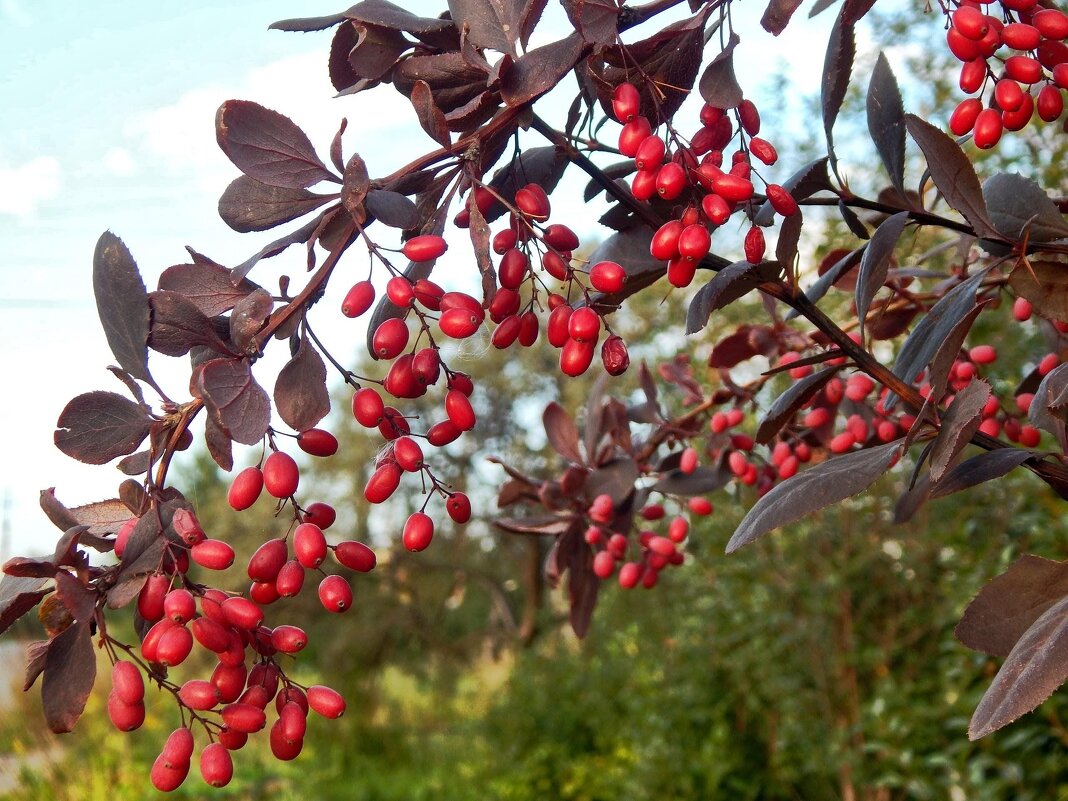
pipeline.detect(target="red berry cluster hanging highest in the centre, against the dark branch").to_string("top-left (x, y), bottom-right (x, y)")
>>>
top-left (612, 83), bottom-right (798, 286)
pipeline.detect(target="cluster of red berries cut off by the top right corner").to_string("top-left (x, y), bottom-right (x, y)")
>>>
top-left (944, 0), bottom-right (1068, 150)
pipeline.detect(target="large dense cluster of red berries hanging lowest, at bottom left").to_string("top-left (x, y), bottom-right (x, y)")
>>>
top-left (106, 501), bottom-right (346, 791)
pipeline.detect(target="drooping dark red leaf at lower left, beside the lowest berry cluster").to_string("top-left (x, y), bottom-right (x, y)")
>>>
top-left (41, 621), bottom-right (96, 734)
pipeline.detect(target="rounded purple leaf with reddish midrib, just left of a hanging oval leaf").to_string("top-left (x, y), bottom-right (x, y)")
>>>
top-left (190, 359), bottom-right (270, 445)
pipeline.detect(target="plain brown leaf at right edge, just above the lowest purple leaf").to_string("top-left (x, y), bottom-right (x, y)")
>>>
top-left (954, 553), bottom-right (1068, 657)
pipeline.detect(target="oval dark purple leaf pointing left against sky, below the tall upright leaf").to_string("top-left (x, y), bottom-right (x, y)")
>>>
top-left (54, 391), bottom-right (152, 465)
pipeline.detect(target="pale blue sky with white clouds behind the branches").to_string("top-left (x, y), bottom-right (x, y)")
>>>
top-left (0, 0), bottom-right (830, 557)
